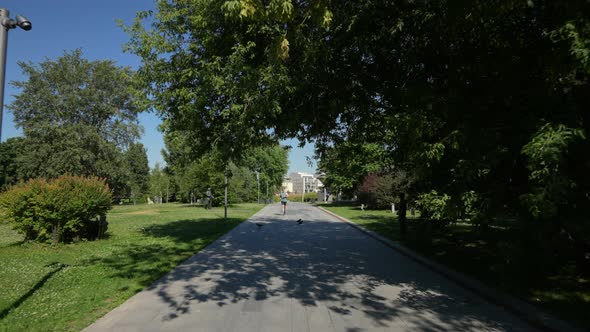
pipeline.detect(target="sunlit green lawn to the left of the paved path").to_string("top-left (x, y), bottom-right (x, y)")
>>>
top-left (0, 204), bottom-right (261, 331)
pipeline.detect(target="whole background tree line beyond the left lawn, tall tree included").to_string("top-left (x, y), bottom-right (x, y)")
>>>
top-left (0, 50), bottom-right (287, 203)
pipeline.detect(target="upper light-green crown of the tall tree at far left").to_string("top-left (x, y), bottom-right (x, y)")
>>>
top-left (9, 50), bottom-right (141, 146)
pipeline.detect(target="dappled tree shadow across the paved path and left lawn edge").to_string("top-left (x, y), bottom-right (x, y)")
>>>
top-left (96, 206), bottom-right (525, 331)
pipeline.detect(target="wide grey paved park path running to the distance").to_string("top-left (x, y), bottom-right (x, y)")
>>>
top-left (84, 203), bottom-right (535, 332)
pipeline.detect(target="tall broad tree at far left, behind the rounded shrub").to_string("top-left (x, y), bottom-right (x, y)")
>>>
top-left (9, 50), bottom-right (141, 194)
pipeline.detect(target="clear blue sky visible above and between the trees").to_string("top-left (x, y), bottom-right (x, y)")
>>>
top-left (0, 0), bottom-right (315, 172)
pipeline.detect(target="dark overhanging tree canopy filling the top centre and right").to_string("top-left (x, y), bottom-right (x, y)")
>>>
top-left (126, 0), bottom-right (590, 268)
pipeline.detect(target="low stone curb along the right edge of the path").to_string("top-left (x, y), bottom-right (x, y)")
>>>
top-left (316, 206), bottom-right (584, 332)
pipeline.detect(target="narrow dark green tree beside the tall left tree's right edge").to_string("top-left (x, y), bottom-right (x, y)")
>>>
top-left (125, 143), bottom-right (150, 204)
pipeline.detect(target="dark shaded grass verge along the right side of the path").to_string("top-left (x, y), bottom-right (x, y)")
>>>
top-left (322, 205), bottom-right (590, 330)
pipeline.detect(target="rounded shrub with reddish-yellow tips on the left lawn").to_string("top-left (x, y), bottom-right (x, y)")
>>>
top-left (0, 176), bottom-right (112, 243)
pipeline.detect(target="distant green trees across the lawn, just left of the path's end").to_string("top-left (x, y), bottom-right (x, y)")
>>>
top-left (152, 139), bottom-right (288, 204)
